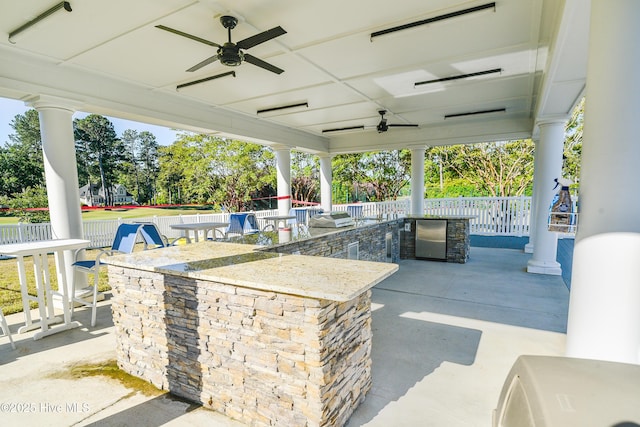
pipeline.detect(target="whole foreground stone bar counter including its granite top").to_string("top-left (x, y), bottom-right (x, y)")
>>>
top-left (107, 242), bottom-right (398, 426)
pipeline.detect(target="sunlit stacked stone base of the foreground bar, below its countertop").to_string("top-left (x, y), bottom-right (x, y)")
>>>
top-left (109, 266), bottom-right (371, 426)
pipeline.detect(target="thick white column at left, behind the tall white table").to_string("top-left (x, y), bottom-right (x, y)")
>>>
top-left (28, 97), bottom-right (86, 289)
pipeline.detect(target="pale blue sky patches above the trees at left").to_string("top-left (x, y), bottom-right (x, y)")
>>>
top-left (0, 98), bottom-right (179, 146)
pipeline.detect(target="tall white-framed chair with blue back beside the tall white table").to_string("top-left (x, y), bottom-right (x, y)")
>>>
top-left (71, 224), bottom-right (143, 326)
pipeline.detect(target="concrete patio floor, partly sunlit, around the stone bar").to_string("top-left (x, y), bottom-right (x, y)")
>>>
top-left (0, 247), bottom-right (569, 427)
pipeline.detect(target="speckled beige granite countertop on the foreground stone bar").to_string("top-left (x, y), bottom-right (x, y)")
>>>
top-left (104, 241), bottom-right (398, 302)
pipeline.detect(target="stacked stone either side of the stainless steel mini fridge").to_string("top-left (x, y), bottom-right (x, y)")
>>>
top-left (400, 218), bottom-right (471, 264)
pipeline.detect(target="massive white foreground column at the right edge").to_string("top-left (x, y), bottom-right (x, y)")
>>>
top-left (567, 0), bottom-right (640, 364)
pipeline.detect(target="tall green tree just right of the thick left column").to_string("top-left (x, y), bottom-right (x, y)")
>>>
top-left (73, 114), bottom-right (125, 205)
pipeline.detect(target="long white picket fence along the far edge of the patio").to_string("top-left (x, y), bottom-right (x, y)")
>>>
top-left (0, 196), bottom-right (556, 248)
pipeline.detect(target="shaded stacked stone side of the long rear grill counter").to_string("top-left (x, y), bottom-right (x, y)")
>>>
top-left (263, 219), bottom-right (404, 263)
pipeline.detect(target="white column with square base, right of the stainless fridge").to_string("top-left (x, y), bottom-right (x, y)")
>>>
top-left (527, 120), bottom-right (565, 276)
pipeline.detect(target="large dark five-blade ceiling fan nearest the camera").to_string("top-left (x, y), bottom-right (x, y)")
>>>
top-left (156, 15), bottom-right (287, 75)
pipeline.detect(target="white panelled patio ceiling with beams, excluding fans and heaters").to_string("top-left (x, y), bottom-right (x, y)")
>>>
top-left (0, 0), bottom-right (589, 153)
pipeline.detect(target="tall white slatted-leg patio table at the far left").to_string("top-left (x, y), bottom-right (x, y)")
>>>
top-left (0, 239), bottom-right (91, 340)
